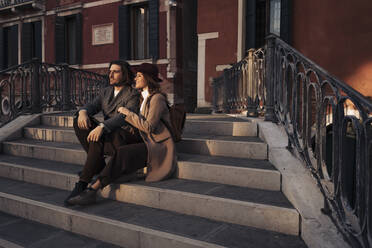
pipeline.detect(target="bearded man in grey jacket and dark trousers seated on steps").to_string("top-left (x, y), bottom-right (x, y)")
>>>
top-left (65, 60), bottom-right (142, 205)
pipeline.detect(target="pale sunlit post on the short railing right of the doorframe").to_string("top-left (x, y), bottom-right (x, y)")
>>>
top-left (246, 48), bottom-right (258, 117)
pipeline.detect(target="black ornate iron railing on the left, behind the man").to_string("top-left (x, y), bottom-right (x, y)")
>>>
top-left (0, 60), bottom-right (108, 126)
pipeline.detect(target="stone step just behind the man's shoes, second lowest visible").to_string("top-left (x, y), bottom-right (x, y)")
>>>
top-left (0, 156), bottom-right (299, 235)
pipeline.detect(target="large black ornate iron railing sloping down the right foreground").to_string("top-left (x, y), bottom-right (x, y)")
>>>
top-left (265, 36), bottom-right (372, 247)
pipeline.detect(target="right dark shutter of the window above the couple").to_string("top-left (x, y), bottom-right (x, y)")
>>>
top-left (149, 0), bottom-right (159, 60)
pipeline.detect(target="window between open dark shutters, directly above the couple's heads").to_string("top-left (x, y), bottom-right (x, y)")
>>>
top-left (131, 4), bottom-right (149, 59)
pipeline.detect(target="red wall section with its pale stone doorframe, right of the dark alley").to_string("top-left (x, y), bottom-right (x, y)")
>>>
top-left (197, 0), bottom-right (238, 107)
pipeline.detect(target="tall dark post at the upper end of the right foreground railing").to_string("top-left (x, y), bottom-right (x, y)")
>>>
top-left (265, 35), bottom-right (277, 122)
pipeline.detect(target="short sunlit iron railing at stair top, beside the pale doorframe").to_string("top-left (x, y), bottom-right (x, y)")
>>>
top-left (212, 48), bottom-right (265, 116)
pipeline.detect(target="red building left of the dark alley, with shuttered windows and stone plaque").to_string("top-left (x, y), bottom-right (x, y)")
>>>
top-left (0, 0), bottom-right (196, 105)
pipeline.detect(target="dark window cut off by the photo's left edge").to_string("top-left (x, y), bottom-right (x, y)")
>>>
top-left (0, 25), bottom-right (18, 69)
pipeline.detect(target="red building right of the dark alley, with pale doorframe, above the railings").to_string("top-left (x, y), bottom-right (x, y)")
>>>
top-left (197, 0), bottom-right (372, 106)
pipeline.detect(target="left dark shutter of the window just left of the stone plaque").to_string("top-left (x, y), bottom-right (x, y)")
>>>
top-left (54, 16), bottom-right (66, 64)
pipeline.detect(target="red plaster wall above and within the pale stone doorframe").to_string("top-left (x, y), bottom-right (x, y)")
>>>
top-left (197, 0), bottom-right (238, 102)
